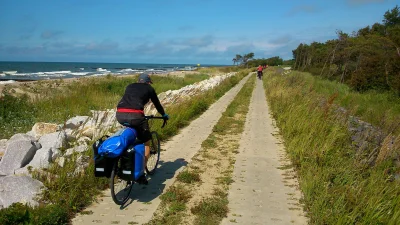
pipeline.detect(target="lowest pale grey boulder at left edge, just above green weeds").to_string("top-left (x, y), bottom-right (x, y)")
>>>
top-left (0, 175), bottom-right (43, 208)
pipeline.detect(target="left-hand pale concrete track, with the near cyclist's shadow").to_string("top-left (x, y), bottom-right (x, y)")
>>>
top-left (72, 75), bottom-right (250, 225)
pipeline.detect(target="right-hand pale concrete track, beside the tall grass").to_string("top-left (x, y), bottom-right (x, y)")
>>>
top-left (222, 79), bottom-right (307, 225)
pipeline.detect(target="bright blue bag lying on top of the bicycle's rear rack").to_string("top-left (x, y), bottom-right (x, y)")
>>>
top-left (98, 127), bottom-right (137, 158)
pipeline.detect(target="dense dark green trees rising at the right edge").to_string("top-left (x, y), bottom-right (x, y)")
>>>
top-left (293, 5), bottom-right (400, 95)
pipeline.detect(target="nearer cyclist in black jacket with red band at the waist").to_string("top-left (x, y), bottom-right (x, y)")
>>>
top-left (116, 73), bottom-right (169, 184)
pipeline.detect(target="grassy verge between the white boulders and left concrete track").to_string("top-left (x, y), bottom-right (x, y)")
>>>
top-left (0, 71), bottom-right (248, 224)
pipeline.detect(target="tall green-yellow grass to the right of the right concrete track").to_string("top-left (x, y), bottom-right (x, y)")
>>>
top-left (264, 70), bottom-right (400, 224)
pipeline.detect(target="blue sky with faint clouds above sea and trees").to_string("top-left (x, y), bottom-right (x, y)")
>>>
top-left (0, 0), bottom-right (399, 64)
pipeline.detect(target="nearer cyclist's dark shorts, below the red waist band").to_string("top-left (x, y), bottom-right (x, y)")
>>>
top-left (116, 112), bottom-right (151, 142)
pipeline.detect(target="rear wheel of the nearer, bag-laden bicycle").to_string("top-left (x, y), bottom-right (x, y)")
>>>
top-left (110, 158), bottom-right (133, 205)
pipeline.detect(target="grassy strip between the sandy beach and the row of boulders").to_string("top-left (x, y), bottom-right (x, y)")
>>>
top-left (0, 73), bottom-right (209, 139)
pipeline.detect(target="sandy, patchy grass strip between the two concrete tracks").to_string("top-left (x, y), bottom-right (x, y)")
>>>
top-left (147, 76), bottom-right (255, 225)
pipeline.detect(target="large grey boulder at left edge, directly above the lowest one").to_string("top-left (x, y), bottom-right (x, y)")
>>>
top-left (0, 140), bottom-right (37, 175)
